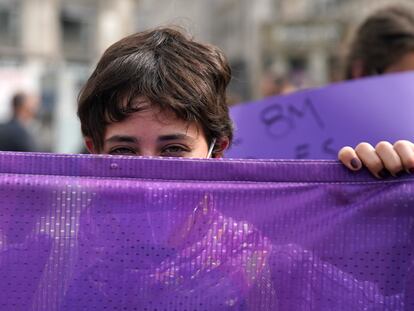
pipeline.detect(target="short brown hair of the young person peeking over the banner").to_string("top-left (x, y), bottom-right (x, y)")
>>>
top-left (78, 28), bottom-right (233, 152)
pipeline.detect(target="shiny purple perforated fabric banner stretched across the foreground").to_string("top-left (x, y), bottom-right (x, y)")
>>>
top-left (0, 153), bottom-right (414, 311)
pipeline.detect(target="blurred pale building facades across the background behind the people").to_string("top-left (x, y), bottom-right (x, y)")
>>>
top-left (0, 0), bottom-right (410, 153)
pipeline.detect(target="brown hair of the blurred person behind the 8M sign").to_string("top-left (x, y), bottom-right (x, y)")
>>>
top-left (345, 6), bottom-right (414, 79)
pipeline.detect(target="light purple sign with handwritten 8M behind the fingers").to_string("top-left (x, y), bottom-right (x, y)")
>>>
top-left (226, 73), bottom-right (414, 159)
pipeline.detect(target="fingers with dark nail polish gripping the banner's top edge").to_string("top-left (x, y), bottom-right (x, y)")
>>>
top-left (338, 140), bottom-right (414, 178)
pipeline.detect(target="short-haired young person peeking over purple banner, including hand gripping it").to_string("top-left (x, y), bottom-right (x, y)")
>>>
top-left (78, 28), bottom-right (414, 178)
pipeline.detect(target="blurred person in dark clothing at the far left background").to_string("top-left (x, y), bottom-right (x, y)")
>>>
top-left (0, 92), bottom-right (39, 152)
